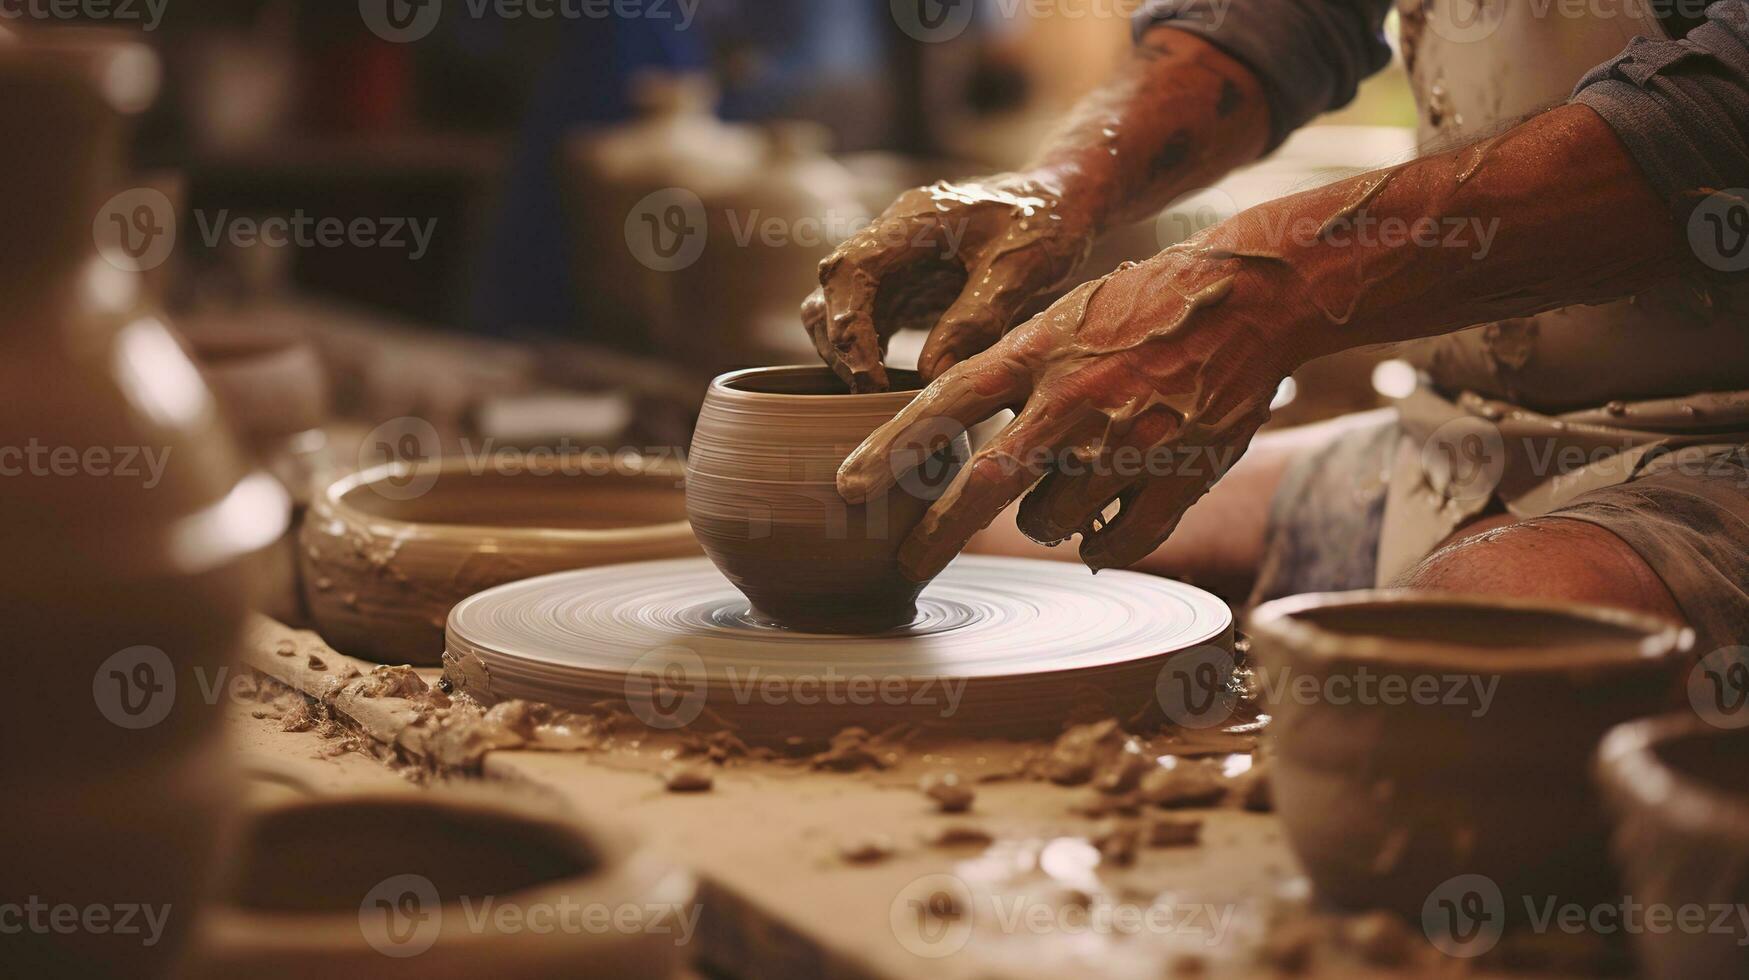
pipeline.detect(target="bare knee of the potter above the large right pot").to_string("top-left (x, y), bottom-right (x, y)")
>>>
top-left (1396, 518), bottom-right (1684, 621)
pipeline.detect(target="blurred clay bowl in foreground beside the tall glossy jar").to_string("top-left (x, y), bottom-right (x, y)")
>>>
top-left (187, 791), bottom-right (696, 980)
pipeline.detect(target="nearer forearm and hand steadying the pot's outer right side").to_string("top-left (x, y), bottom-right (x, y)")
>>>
top-left (838, 107), bottom-right (1683, 576)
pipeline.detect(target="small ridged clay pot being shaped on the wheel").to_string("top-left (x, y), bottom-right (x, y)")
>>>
top-left (686, 368), bottom-right (971, 634)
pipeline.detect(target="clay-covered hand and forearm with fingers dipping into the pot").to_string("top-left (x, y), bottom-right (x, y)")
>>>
top-left (803, 28), bottom-right (1268, 392)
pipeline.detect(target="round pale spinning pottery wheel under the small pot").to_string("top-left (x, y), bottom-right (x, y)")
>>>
top-left (444, 557), bottom-right (1233, 740)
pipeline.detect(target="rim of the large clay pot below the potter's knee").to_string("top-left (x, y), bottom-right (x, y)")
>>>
top-left (1245, 590), bottom-right (1695, 674)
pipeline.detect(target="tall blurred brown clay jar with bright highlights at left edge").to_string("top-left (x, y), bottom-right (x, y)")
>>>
top-left (0, 30), bottom-right (289, 977)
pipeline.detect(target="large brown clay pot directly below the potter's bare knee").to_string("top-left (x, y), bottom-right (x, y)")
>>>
top-left (1251, 592), bottom-right (1693, 919)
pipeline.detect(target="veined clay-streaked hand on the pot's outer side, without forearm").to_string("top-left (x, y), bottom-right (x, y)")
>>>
top-left (838, 250), bottom-right (1291, 581)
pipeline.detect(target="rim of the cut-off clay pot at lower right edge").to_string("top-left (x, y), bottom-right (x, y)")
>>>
top-left (1595, 714), bottom-right (1749, 840)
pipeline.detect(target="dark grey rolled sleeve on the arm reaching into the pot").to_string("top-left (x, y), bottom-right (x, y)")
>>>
top-left (1135, 0), bottom-right (1392, 149)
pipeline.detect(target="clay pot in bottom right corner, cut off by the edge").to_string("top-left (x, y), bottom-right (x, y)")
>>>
top-left (1597, 714), bottom-right (1749, 980)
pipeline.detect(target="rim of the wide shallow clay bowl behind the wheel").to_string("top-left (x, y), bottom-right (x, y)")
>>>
top-left (322, 453), bottom-right (693, 544)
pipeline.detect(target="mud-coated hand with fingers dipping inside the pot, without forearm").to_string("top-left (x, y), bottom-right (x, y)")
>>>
top-left (801, 175), bottom-right (1093, 392)
